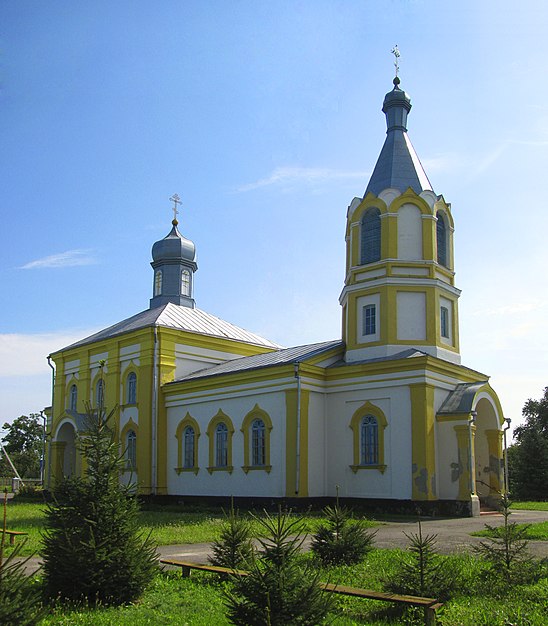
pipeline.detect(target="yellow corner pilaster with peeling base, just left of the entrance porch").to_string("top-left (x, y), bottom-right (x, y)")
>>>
top-left (409, 383), bottom-right (437, 500)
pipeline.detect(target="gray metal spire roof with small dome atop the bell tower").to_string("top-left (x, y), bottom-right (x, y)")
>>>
top-left (364, 81), bottom-right (432, 196)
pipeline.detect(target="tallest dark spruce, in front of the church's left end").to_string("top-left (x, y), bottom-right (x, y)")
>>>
top-left (42, 382), bottom-right (157, 605)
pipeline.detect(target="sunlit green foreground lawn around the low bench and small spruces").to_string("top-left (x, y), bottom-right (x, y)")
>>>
top-left (35, 550), bottom-right (548, 626)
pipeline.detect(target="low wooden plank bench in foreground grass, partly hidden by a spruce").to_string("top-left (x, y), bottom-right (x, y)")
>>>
top-left (160, 559), bottom-right (443, 626)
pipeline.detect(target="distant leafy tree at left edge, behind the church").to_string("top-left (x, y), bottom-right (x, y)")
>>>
top-left (0, 413), bottom-right (43, 478)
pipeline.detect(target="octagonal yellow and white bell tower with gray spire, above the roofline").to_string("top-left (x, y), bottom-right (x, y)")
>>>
top-left (340, 75), bottom-right (460, 364)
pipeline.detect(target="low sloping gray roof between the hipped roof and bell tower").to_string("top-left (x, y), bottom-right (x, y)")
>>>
top-left (168, 340), bottom-right (344, 384)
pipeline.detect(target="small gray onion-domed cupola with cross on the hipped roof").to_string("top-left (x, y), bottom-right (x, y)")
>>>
top-left (150, 195), bottom-right (198, 309)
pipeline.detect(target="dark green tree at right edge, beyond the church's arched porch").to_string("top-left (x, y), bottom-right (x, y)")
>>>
top-left (508, 387), bottom-right (548, 500)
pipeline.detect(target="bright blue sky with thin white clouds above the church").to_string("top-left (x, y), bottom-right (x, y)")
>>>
top-left (0, 0), bottom-right (548, 434)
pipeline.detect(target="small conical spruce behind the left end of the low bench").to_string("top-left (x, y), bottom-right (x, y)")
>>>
top-left (209, 502), bottom-right (255, 569)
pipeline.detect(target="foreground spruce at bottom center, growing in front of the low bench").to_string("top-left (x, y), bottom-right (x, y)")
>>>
top-left (225, 511), bottom-right (331, 626)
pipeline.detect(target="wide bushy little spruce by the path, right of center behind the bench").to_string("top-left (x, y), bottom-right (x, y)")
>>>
top-left (311, 497), bottom-right (376, 565)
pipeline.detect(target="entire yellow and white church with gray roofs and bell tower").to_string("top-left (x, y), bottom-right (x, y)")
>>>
top-left (46, 77), bottom-right (504, 515)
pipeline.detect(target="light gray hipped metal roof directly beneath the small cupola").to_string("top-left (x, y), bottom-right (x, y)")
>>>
top-left (55, 302), bottom-right (280, 350)
